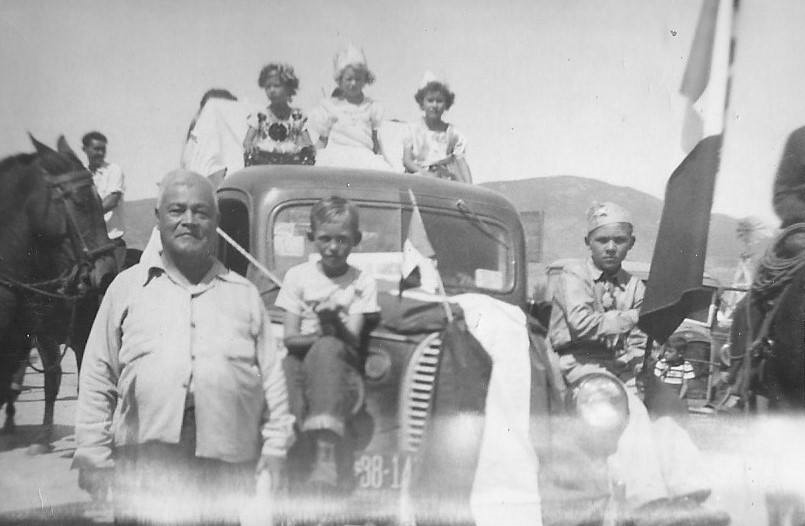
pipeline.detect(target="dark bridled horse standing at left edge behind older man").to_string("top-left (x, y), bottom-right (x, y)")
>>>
top-left (0, 137), bottom-right (117, 452)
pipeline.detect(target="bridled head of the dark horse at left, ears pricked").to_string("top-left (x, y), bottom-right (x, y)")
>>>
top-left (28, 137), bottom-right (116, 287)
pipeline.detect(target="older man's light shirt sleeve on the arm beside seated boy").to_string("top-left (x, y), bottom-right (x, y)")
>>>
top-left (256, 308), bottom-right (294, 457)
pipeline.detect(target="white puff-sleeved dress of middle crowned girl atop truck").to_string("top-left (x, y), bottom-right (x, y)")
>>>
top-left (308, 97), bottom-right (391, 170)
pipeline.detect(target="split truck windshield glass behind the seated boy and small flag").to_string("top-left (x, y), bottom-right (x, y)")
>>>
top-left (266, 203), bottom-right (514, 293)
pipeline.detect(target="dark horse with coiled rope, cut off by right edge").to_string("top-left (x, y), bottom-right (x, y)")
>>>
top-left (729, 223), bottom-right (805, 412)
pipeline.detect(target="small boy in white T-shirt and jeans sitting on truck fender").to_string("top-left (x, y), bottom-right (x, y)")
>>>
top-left (276, 197), bottom-right (380, 491)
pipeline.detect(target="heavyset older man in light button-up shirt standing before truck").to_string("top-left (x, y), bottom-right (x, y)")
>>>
top-left (74, 171), bottom-right (293, 523)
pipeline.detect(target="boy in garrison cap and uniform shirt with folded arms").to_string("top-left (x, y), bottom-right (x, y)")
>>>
top-left (548, 202), bottom-right (646, 379)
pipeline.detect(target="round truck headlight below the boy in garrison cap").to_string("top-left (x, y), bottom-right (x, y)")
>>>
top-left (575, 373), bottom-right (629, 436)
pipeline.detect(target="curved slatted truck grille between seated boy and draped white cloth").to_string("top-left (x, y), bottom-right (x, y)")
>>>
top-left (400, 333), bottom-right (442, 453)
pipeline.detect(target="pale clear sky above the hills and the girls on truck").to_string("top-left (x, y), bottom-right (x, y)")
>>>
top-left (0, 0), bottom-right (805, 229)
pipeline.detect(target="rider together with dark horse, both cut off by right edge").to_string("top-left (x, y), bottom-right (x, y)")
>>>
top-left (725, 127), bottom-right (805, 412)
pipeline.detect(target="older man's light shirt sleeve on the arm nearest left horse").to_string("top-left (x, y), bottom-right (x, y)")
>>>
top-left (73, 284), bottom-right (121, 469)
